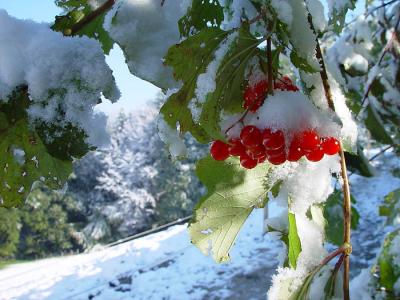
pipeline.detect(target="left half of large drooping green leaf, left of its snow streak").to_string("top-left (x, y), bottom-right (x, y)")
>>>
top-left (160, 28), bottom-right (228, 143)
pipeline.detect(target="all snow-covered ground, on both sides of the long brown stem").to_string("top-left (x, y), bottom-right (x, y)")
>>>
top-left (0, 153), bottom-right (400, 300)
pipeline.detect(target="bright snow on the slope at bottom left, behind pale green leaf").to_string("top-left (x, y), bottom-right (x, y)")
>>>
top-left (0, 210), bottom-right (278, 300)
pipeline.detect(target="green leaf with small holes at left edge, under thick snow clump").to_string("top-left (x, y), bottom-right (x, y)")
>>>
top-left (0, 90), bottom-right (72, 207)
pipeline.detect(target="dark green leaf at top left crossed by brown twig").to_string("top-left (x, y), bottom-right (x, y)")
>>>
top-left (51, 0), bottom-right (114, 54)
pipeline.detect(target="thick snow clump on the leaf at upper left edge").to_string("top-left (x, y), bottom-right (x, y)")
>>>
top-left (0, 10), bottom-right (119, 146)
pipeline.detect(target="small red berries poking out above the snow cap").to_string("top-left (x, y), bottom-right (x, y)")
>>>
top-left (243, 76), bottom-right (299, 112)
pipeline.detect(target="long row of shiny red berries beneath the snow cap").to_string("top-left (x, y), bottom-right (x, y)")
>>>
top-left (210, 125), bottom-right (340, 169)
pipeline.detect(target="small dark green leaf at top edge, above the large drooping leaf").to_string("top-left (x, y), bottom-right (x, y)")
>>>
top-left (178, 0), bottom-right (224, 37)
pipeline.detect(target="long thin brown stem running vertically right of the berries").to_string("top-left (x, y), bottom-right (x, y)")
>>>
top-left (308, 13), bottom-right (351, 300)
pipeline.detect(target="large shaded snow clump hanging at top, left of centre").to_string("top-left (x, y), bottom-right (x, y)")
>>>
top-left (104, 0), bottom-right (191, 88)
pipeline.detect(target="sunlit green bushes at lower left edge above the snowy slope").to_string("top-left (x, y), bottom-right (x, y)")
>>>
top-left (0, 185), bottom-right (83, 259)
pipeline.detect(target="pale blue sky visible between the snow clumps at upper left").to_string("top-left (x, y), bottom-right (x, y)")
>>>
top-left (0, 0), bottom-right (160, 116)
